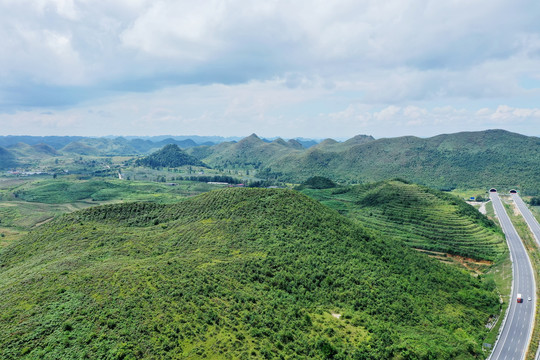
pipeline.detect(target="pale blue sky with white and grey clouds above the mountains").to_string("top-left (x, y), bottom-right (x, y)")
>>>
top-left (0, 0), bottom-right (540, 138)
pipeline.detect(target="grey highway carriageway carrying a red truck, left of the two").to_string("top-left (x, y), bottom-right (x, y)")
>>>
top-left (489, 193), bottom-right (536, 360)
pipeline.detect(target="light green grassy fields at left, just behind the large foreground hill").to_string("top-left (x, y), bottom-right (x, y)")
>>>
top-left (0, 177), bottom-right (224, 247)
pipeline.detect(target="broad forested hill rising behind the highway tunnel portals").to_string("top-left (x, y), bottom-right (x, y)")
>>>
top-left (252, 130), bottom-right (540, 195)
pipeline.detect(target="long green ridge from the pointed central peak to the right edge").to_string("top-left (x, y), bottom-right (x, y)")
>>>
top-left (189, 130), bottom-right (540, 195)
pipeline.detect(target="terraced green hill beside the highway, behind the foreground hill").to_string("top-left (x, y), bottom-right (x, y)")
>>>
top-left (304, 180), bottom-right (505, 261)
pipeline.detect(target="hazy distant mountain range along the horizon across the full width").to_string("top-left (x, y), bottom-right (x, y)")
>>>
top-left (0, 130), bottom-right (540, 195)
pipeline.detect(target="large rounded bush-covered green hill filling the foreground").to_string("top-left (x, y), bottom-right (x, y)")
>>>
top-left (0, 188), bottom-right (499, 359)
